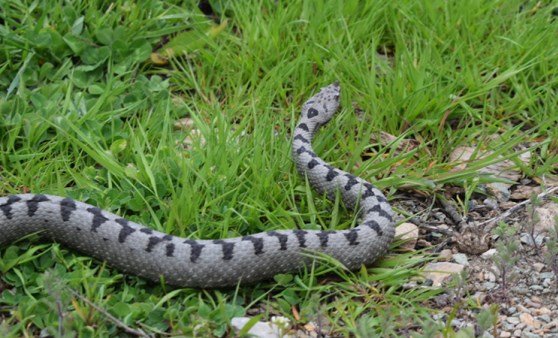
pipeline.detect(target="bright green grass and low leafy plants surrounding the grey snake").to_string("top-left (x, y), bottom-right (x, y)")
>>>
top-left (0, 0), bottom-right (558, 337)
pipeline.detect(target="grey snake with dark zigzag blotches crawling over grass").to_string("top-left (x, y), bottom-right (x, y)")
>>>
top-left (0, 82), bottom-right (395, 288)
